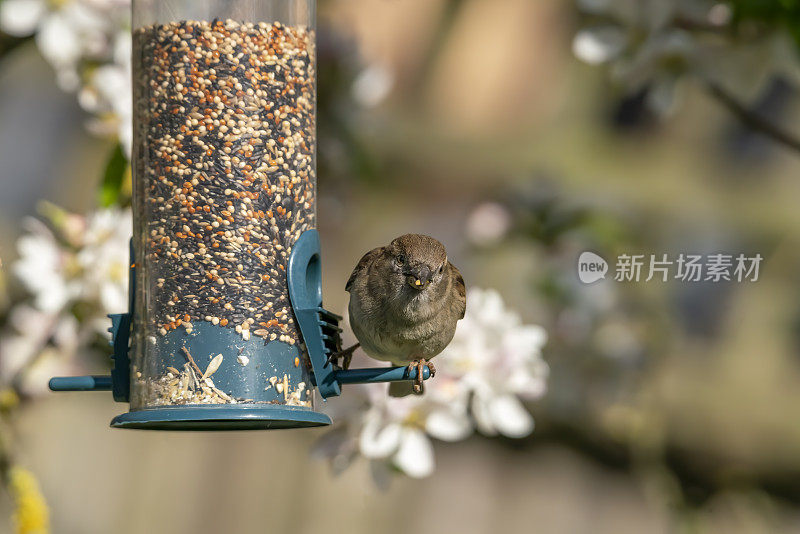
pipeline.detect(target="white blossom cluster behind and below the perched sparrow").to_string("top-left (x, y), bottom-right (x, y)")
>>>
top-left (317, 289), bottom-right (548, 484)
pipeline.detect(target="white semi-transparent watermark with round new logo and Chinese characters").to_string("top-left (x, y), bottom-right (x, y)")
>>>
top-left (578, 252), bottom-right (763, 284)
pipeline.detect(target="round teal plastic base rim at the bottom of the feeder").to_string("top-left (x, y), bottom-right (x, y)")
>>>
top-left (111, 404), bottom-right (331, 430)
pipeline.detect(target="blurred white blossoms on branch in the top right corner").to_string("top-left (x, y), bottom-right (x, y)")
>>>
top-left (572, 0), bottom-right (800, 115)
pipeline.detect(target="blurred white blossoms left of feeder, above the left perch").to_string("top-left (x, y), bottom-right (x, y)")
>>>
top-left (0, 207), bottom-right (132, 393)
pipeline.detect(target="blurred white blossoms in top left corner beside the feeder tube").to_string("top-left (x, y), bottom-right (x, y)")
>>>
top-left (0, 0), bottom-right (132, 154)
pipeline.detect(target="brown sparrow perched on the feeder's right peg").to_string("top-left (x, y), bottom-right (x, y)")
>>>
top-left (344, 234), bottom-right (467, 396)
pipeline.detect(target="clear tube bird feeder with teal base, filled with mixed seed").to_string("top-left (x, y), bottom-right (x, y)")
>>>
top-left (50, 0), bottom-right (429, 430)
